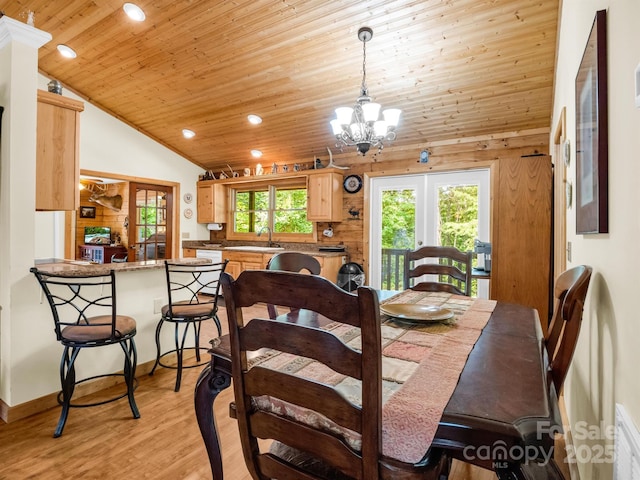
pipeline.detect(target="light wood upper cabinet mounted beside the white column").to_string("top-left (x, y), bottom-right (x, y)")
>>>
top-left (36, 90), bottom-right (84, 210)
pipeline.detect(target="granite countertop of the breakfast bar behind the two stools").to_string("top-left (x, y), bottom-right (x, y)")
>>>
top-left (34, 258), bottom-right (210, 277)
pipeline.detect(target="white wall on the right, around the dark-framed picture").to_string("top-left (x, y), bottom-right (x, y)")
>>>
top-left (551, 0), bottom-right (640, 480)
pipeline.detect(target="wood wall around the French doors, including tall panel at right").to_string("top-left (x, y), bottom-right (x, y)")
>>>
top-left (210, 129), bottom-right (552, 322)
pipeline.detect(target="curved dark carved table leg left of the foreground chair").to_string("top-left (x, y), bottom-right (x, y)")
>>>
top-left (194, 357), bottom-right (231, 480)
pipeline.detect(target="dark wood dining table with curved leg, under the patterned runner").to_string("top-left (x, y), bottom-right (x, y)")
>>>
top-left (195, 294), bottom-right (563, 480)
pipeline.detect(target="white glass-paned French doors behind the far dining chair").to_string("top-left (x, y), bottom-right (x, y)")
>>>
top-left (367, 169), bottom-right (490, 298)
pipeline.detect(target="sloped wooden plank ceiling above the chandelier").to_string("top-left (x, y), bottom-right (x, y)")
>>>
top-left (0, 0), bottom-right (558, 173)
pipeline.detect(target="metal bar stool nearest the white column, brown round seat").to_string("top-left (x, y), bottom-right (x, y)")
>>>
top-left (30, 268), bottom-right (140, 437)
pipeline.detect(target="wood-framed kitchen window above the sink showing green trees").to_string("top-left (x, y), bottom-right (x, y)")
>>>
top-left (228, 179), bottom-right (316, 242)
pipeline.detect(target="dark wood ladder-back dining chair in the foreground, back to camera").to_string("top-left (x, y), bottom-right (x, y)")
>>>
top-left (220, 270), bottom-right (449, 480)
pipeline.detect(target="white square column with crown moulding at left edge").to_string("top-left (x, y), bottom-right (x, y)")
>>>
top-left (0, 16), bottom-right (51, 411)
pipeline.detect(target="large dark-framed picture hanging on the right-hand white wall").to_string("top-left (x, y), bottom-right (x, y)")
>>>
top-left (574, 10), bottom-right (609, 234)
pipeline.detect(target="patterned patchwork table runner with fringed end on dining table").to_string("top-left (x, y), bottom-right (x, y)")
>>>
top-left (250, 290), bottom-right (496, 463)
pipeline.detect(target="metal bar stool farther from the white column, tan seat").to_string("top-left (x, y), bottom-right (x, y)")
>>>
top-left (149, 260), bottom-right (228, 392)
